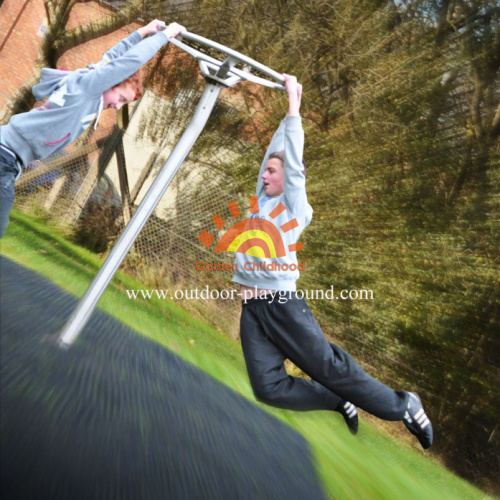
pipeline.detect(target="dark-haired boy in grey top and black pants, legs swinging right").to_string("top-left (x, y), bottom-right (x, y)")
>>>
top-left (233, 75), bottom-right (433, 448)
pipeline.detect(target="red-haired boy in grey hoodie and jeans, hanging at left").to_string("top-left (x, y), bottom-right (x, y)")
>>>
top-left (0, 20), bottom-right (185, 237)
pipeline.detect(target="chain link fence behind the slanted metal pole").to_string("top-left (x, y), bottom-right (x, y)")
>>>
top-left (12, 85), bottom-right (248, 338)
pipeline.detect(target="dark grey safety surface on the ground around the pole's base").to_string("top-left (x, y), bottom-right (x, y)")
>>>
top-left (0, 257), bottom-right (324, 500)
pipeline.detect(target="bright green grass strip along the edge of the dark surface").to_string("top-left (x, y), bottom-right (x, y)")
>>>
top-left (0, 211), bottom-right (487, 500)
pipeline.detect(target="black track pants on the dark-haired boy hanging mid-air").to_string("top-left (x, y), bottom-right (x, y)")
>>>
top-left (240, 292), bottom-right (407, 420)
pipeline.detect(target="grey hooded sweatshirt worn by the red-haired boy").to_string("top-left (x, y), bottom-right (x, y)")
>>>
top-left (0, 31), bottom-right (168, 165)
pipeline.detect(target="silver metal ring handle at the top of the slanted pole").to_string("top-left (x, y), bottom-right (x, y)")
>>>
top-left (169, 31), bottom-right (285, 89)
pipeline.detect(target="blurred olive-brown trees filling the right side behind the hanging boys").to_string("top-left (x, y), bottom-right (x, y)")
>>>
top-left (190, 0), bottom-right (500, 492)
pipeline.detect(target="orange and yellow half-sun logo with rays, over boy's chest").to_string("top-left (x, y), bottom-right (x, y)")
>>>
top-left (198, 196), bottom-right (303, 259)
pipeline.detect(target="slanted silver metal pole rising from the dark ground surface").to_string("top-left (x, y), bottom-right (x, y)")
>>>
top-left (58, 83), bottom-right (223, 348)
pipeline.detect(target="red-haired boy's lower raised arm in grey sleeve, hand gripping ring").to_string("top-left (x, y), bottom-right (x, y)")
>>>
top-left (80, 21), bottom-right (185, 95)
